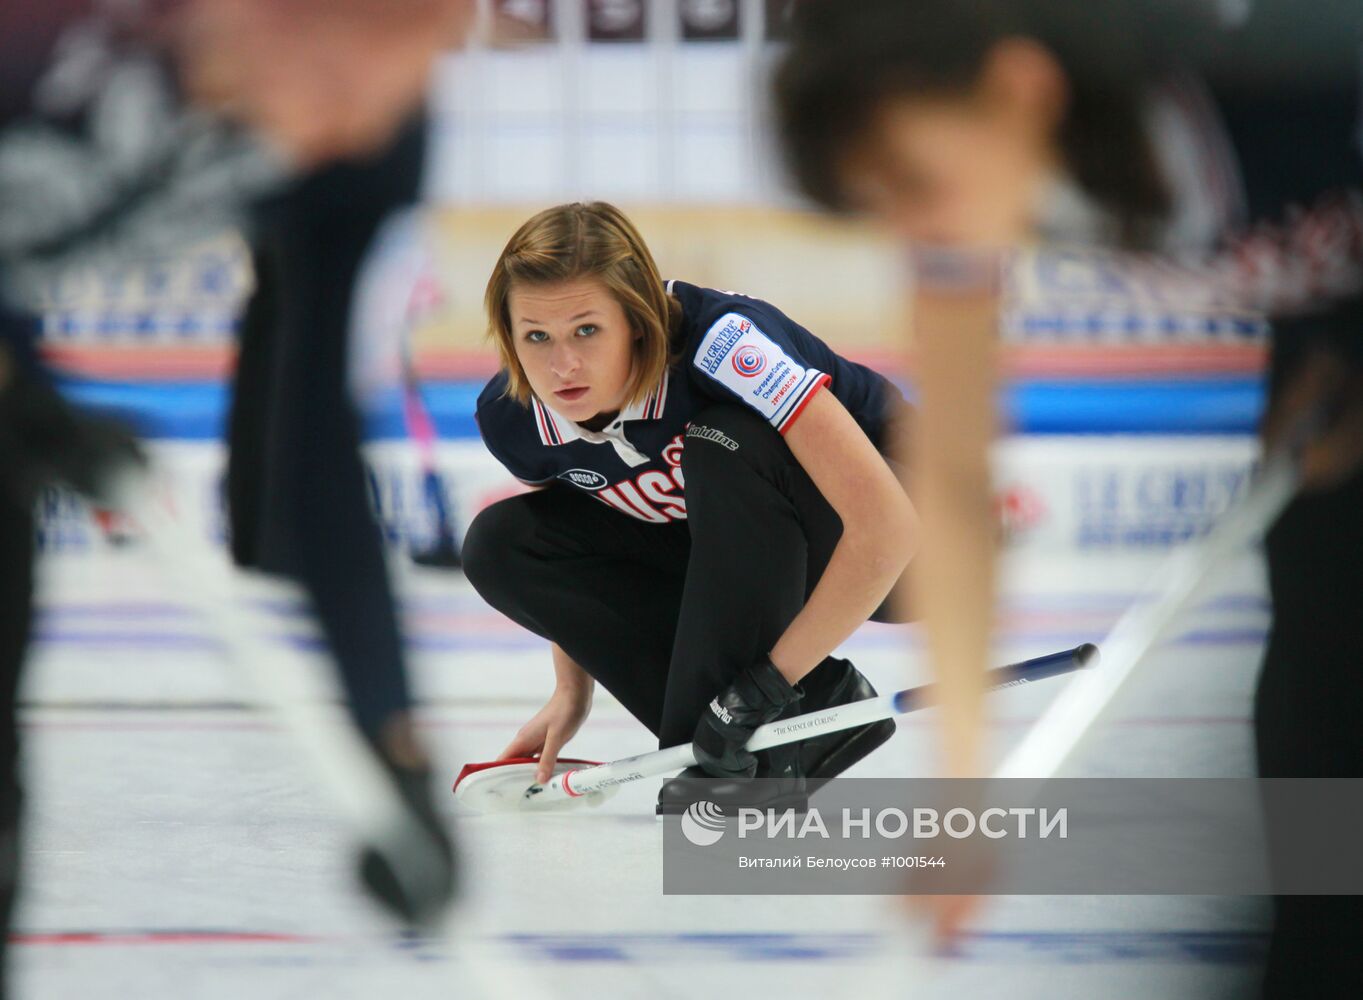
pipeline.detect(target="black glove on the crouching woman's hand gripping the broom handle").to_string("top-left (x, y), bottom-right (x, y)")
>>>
top-left (691, 657), bottom-right (804, 778)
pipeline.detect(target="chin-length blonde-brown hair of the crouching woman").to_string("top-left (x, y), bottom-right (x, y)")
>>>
top-left (483, 202), bottom-right (682, 406)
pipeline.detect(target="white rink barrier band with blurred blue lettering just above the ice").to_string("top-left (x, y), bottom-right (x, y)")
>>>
top-left (38, 435), bottom-right (1257, 554)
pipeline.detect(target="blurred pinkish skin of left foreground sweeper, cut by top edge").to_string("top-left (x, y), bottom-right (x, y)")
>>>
top-left (169, 0), bottom-right (474, 169)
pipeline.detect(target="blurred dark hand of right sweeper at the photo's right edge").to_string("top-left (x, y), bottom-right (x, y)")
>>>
top-left (1262, 350), bottom-right (1363, 490)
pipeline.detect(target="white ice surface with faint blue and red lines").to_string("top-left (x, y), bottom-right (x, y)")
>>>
top-left (11, 549), bottom-right (1268, 1000)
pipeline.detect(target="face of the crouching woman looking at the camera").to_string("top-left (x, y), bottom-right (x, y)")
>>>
top-left (507, 278), bottom-right (639, 424)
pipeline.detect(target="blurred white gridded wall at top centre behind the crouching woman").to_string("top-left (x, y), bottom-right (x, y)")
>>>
top-left (431, 0), bottom-right (792, 204)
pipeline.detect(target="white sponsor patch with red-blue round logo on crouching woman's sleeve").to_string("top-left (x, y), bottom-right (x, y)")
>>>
top-left (694, 312), bottom-right (829, 431)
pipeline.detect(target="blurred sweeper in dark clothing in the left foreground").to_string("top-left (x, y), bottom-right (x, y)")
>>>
top-left (0, 0), bottom-right (473, 986)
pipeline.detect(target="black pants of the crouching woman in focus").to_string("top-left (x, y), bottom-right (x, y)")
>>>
top-left (463, 405), bottom-right (889, 747)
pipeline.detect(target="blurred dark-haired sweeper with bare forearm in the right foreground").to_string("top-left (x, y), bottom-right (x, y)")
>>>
top-left (776, 0), bottom-right (1363, 997)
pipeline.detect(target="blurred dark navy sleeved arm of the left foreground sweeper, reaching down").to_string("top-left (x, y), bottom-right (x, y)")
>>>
top-left (228, 117), bottom-right (425, 740)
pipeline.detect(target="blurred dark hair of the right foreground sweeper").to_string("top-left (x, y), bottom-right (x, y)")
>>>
top-left (774, 0), bottom-right (1221, 244)
